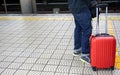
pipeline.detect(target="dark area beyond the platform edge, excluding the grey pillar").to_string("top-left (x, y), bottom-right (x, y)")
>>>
top-left (0, 0), bottom-right (120, 13)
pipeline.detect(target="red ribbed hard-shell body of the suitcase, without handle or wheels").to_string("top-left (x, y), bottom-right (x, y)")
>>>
top-left (91, 37), bottom-right (116, 68)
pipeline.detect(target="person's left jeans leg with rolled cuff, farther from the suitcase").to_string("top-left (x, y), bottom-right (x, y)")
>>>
top-left (74, 18), bottom-right (82, 54)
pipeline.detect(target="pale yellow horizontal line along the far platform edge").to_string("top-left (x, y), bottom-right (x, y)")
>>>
top-left (0, 16), bottom-right (120, 21)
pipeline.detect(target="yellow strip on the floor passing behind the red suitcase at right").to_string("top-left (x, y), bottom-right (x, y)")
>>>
top-left (108, 20), bottom-right (120, 69)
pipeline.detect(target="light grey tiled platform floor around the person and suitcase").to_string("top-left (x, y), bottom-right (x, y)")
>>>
top-left (0, 13), bottom-right (120, 75)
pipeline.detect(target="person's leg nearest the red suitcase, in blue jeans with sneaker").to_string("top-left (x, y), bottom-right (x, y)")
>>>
top-left (81, 9), bottom-right (92, 63)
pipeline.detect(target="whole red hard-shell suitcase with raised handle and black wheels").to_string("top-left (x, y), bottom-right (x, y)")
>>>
top-left (90, 5), bottom-right (116, 71)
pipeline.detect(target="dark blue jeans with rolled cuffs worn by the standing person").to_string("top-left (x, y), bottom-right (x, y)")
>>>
top-left (73, 8), bottom-right (92, 54)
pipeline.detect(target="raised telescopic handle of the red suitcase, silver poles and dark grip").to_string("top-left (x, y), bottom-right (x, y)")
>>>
top-left (96, 4), bottom-right (108, 34)
